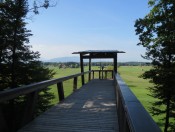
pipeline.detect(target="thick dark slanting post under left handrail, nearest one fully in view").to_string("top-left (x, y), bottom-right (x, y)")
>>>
top-left (21, 91), bottom-right (38, 127)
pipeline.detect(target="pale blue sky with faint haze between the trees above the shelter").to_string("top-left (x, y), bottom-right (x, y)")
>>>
top-left (27, 0), bottom-right (150, 62)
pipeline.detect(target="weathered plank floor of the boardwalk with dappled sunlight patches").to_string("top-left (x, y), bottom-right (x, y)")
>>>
top-left (19, 79), bottom-right (119, 132)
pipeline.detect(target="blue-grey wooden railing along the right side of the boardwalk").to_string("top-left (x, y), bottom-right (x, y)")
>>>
top-left (114, 74), bottom-right (161, 132)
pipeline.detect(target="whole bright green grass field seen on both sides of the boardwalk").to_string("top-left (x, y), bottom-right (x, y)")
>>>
top-left (49, 66), bottom-right (163, 129)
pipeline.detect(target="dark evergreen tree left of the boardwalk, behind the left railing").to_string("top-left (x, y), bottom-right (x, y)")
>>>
top-left (0, 0), bottom-right (54, 131)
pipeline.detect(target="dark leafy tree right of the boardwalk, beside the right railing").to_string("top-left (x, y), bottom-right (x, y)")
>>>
top-left (135, 0), bottom-right (175, 132)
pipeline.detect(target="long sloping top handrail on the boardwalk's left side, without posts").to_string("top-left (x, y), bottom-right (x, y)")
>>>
top-left (0, 71), bottom-right (91, 102)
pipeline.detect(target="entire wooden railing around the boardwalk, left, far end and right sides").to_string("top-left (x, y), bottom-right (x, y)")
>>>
top-left (0, 70), bottom-right (160, 132)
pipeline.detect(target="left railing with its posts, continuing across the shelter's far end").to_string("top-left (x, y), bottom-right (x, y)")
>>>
top-left (0, 70), bottom-right (112, 131)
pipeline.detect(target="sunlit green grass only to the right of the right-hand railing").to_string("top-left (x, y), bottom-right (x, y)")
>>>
top-left (118, 66), bottom-right (164, 130)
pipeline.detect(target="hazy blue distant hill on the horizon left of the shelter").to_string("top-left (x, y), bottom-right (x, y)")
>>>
top-left (44, 56), bottom-right (80, 62)
